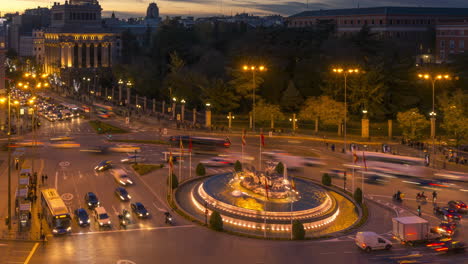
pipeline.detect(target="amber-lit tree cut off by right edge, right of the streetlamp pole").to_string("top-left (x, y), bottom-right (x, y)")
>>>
top-left (441, 90), bottom-right (468, 148)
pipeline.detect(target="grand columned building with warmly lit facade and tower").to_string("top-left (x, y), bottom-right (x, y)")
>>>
top-left (43, 0), bottom-right (117, 76)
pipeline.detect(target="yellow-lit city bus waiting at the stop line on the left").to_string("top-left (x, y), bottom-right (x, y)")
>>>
top-left (41, 188), bottom-right (71, 235)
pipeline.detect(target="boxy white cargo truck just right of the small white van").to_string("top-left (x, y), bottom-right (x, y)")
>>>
top-left (392, 216), bottom-right (438, 243)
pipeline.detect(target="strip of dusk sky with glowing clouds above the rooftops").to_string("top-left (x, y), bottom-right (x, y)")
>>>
top-left (0, 0), bottom-right (468, 18)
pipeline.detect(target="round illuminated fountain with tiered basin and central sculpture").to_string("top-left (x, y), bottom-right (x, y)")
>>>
top-left (176, 163), bottom-right (353, 236)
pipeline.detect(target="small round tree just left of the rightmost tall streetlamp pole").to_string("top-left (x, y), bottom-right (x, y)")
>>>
top-left (397, 108), bottom-right (429, 140)
